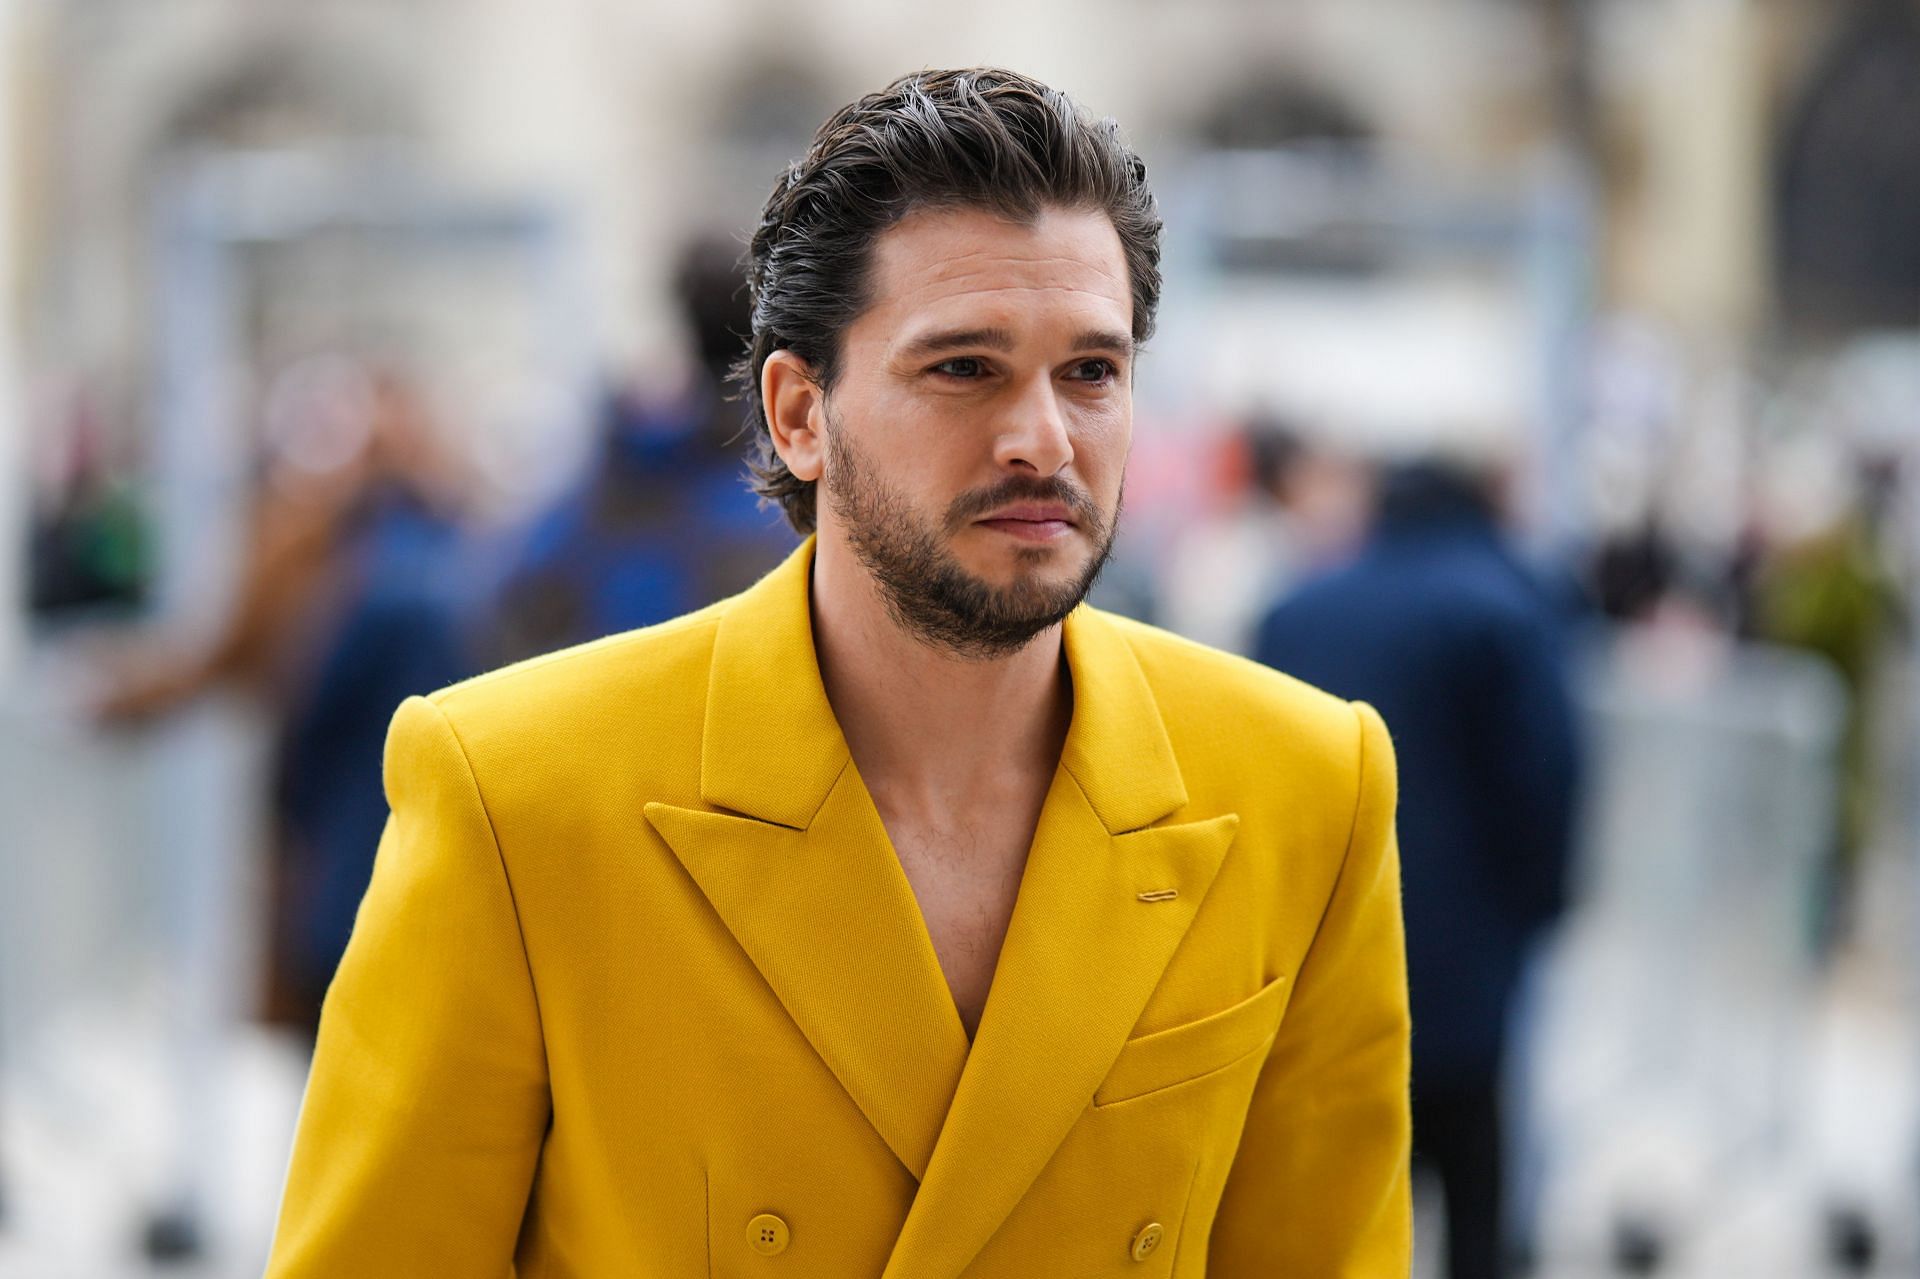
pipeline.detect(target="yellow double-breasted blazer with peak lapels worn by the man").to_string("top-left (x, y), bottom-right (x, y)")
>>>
top-left (269, 542), bottom-right (1411, 1279)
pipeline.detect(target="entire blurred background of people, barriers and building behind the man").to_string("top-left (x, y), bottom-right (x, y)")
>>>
top-left (0, 0), bottom-right (1920, 1279)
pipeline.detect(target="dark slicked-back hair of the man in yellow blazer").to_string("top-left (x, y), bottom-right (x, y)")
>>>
top-left (733, 67), bottom-right (1160, 534)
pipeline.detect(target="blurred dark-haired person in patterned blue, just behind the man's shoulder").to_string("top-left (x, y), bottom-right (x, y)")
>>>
top-left (484, 238), bottom-right (793, 663)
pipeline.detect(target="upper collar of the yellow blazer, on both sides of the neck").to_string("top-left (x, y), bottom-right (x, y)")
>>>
top-left (701, 538), bottom-right (1187, 835)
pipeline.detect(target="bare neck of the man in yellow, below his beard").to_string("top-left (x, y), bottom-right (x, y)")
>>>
top-left (810, 533), bottom-right (1073, 808)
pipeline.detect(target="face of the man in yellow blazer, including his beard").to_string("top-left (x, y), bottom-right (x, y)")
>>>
top-left (820, 209), bottom-right (1133, 657)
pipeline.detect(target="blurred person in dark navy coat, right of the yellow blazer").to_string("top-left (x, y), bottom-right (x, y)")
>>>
top-left (1256, 461), bottom-right (1578, 1279)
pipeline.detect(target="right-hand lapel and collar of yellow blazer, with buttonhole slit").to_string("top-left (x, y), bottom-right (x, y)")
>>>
top-left (885, 611), bottom-right (1238, 1279)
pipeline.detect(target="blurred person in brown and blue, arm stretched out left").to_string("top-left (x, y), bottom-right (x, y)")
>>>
top-left (96, 357), bottom-right (474, 1035)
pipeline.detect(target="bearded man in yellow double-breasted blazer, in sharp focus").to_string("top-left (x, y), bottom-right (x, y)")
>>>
top-left (271, 71), bottom-right (1409, 1279)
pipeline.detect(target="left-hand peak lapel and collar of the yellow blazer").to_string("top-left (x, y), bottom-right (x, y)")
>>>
top-left (647, 538), bottom-right (968, 1179)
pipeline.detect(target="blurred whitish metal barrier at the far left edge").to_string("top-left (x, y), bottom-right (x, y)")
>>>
top-left (0, 663), bottom-right (267, 1262)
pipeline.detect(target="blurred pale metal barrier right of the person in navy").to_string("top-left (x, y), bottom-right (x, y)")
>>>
top-left (1517, 632), bottom-right (1845, 1271)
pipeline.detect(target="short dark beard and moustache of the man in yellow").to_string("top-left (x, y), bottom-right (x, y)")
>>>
top-left (822, 422), bottom-right (1119, 661)
